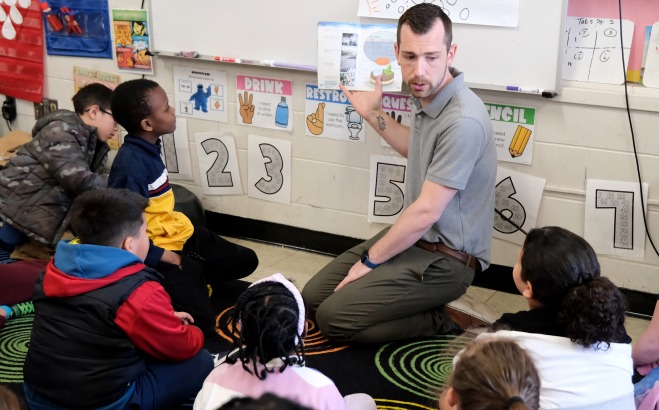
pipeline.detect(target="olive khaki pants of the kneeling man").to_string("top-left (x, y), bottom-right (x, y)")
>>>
top-left (302, 228), bottom-right (475, 343)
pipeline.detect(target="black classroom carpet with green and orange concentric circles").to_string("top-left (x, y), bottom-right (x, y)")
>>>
top-left (0, 281), bottom-right (475, 410)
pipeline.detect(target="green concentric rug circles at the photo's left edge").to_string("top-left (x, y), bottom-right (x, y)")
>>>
top-left (0, 314), bottom-right (34, 383)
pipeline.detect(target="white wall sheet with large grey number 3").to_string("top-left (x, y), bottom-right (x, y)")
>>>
top-left (247, 134), bottom-right (291, 205)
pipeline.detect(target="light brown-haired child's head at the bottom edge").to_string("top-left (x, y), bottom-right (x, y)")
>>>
top-left (439, 339), bottom-right (540, 410)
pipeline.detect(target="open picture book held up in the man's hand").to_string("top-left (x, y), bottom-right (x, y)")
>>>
top-left (318, 21), bottom-right (403, 91)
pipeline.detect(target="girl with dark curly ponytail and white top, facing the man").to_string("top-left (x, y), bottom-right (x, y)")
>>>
top-left (478, 226), bottom-right (634, 410)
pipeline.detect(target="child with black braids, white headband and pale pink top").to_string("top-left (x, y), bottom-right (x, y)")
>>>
top-left (194, 273), bottom-right (375, 410)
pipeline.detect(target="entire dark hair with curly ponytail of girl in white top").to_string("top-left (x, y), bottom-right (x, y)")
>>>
top-left (520, 226), bottom-right (627, 348)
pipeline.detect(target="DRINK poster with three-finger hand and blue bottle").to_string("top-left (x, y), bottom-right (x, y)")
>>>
top-left (236, 75), bottom-right (293, 131)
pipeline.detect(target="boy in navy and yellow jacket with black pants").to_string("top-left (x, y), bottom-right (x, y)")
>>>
top-left (108, 79), bottom-right (258, 333)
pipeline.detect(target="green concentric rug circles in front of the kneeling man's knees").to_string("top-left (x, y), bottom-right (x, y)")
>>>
top-left (375, 336), bottom-right (471, 398)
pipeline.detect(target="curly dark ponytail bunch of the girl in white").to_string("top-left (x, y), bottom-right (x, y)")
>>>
top-left (558, 277), bottom-right (628, 349)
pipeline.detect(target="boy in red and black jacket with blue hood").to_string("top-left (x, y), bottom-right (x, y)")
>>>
top-left (23, 188), bottom-right (213, 410)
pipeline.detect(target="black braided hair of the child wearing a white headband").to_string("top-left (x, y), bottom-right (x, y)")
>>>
top-left (227, 282), bottom-right (304, 380)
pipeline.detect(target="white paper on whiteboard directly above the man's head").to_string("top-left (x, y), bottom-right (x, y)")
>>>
top-left (357, 0), bottom-right (519, 27)
